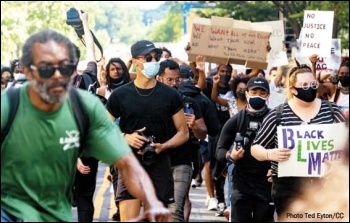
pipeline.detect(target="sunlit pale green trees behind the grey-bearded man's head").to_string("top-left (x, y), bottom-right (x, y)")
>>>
top-left (1, 1), bottom-right (102, 64)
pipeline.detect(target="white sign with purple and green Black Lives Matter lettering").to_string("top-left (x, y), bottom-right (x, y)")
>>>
top-left (277, 123), bottom-right (348, 177)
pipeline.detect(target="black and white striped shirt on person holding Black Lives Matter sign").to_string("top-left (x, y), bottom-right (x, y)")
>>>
top-left (252, 100), bottom-right (345, 176)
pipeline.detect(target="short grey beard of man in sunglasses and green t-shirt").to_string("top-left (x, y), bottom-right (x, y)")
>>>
top-left (30, 78), bottom-right (72, 104)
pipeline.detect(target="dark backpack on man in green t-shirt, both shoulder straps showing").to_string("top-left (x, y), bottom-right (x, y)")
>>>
top-left (1, 87), bottom-right (89, 155)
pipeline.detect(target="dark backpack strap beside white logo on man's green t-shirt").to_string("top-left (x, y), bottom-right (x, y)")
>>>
top-left (69, 87), bottom-right (89, 155)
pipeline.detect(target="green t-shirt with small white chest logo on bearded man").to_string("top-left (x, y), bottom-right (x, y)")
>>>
top-left (1, 84), bottom-right (131, 222)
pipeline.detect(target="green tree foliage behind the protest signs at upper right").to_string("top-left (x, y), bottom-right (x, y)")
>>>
top-left (197, 1), bottom-right (349, 49)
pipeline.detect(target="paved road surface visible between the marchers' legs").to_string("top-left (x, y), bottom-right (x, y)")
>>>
top-left (72, 163), bottom-right (227, 222)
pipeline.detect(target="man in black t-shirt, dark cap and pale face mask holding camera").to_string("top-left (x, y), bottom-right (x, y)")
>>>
top-left (106, 40), bottom-right (189, 221)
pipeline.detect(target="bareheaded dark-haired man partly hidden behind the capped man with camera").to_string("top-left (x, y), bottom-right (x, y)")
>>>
top-left (157, 59), bottom-right (207, 222)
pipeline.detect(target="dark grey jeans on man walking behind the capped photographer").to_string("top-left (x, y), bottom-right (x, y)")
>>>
top-left (169, 164), bottom-right (193, 222)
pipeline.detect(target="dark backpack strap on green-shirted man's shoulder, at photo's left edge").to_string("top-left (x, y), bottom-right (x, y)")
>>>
top-left (1, 87), bottom-right (20, 144)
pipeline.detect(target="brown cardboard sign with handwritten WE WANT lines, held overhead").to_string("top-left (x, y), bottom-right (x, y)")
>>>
top-left (188, 16), bottom-right (272, 69)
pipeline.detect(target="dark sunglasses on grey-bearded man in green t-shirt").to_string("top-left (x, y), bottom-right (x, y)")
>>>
top-left (30, 64), bottom-right (77, 79)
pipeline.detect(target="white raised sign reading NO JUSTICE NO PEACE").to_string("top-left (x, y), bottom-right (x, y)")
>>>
top-left (299, 10), bottom-right (334, 57)
